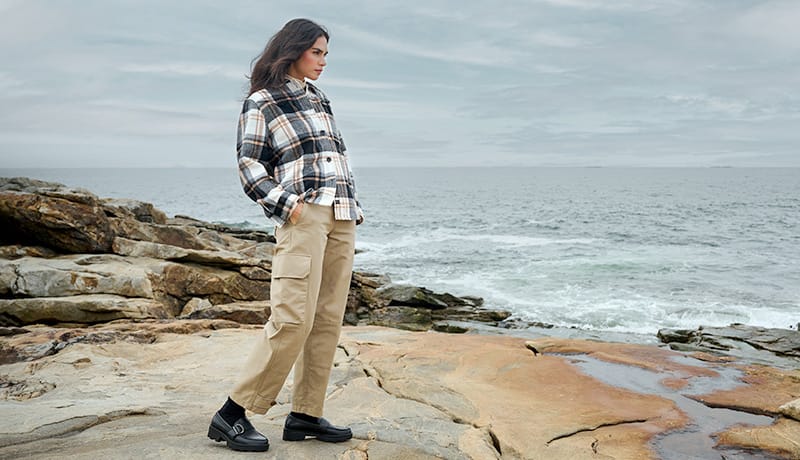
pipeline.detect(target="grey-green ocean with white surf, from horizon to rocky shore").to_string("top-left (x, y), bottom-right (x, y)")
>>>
top-left (0, 168), bottom-right (800, 337)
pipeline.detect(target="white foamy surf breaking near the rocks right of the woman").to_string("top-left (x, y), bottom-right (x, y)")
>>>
top-left (364, 270), bottom-right (799, 336)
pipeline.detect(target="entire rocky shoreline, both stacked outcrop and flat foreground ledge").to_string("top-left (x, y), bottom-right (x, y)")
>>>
top-left (0, 178), bottom-right (800, 460)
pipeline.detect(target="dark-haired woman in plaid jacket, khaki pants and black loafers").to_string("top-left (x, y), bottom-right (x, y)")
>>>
top-left (208, 19), bottom-right (363, 451)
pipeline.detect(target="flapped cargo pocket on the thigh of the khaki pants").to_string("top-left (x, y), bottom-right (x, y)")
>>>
top-left (270, 254), bottom-right (311, 325)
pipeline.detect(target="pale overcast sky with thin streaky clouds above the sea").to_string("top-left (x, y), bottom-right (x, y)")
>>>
top-left (0, 0), bottom-right (800, 168)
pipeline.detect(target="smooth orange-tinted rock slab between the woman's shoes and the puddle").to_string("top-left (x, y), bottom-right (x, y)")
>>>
top-left (350, 328), bottom-right (687, 459)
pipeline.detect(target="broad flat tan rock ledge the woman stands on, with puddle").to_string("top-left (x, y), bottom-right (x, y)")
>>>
top-left (0, 320), bottom-right (800, 460)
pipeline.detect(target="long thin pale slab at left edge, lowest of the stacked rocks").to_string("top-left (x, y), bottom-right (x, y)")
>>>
top-left (0, 294), bottom-right (172, 326)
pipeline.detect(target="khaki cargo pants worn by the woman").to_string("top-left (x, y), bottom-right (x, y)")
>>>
top-left (230, 203), bottom-right (355, 417)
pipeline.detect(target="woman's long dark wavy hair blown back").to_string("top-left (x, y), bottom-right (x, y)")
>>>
top-left (247, 19), bottom-right (330, 95)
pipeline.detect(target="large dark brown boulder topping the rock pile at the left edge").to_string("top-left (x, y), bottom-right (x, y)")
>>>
top-left (0, 192), bottom-right (114, 253)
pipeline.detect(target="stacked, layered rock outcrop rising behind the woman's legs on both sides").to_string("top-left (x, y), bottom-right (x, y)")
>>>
top-left (0, 178), bottom-right (510, 329)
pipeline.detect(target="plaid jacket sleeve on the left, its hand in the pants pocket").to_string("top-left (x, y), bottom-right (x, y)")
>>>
top-left (236, 99), bottom-right (299, 227)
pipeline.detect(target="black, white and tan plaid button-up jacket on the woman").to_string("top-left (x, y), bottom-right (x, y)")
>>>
top-left (236, 79), bottom-right (363, 227)
